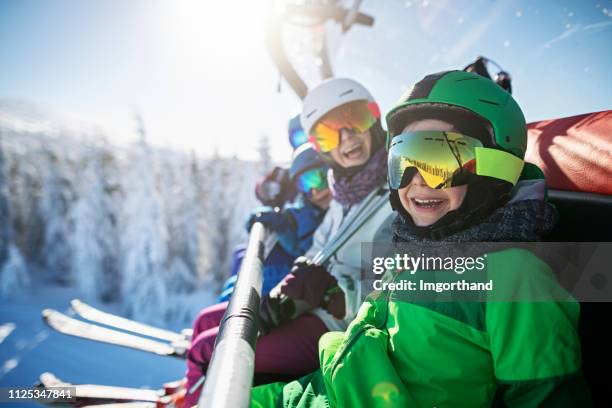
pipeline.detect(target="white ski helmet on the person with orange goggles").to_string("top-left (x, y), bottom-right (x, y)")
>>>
top-left (300, 78), bottom-right (375, 135)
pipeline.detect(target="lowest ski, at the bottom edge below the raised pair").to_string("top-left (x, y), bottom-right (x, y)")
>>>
top-left (36, 372), bottom-right (172, 408)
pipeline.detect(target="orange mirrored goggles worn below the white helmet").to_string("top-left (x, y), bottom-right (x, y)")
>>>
top-left (308, 100), bottom-right (380, 153)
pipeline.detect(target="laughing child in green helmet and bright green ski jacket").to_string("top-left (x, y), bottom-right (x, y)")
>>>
top-left (252, 71), bottom-right (590, 408)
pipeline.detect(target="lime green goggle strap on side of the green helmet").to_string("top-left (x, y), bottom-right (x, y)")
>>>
top-left (474, 147), bottom-right (525, 185)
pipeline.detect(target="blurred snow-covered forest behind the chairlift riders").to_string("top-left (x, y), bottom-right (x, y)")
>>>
top-left (0, 107), bottom-right (270, 324)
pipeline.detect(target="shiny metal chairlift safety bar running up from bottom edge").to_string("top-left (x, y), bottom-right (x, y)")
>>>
top-left (198, 222), bottom-right (267, 408)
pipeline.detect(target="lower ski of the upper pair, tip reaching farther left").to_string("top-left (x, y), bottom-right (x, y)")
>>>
top-left (42, 309), bottom-right (189, 358)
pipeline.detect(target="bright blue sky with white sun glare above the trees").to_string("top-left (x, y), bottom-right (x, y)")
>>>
top-left (0, 0), bottom-right (612, 160)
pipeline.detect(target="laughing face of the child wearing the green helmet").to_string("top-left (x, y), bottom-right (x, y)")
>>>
top-left (398, 119), bottom-right (468, 227)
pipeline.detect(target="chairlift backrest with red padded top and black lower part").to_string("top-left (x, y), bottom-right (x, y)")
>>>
top-left (526, 110), bottom-right (612, 406)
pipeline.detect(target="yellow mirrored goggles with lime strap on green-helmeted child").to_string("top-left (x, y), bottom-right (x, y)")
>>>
top-left (388, 131), bottom-right (525, 189)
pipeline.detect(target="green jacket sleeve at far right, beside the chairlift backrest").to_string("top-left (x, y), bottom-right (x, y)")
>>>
top-left (486, 250), bottom-right (590, 407)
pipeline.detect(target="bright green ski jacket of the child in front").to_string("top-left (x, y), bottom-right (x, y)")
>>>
top-left (252, 248), bottom-right (590, 408)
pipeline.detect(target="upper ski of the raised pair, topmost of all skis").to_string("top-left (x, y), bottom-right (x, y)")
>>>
top-left (70, 299), bottom-right (191, 343)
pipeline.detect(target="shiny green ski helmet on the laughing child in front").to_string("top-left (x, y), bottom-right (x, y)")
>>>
top-left (386, 71), bottom-right (527, 188)
